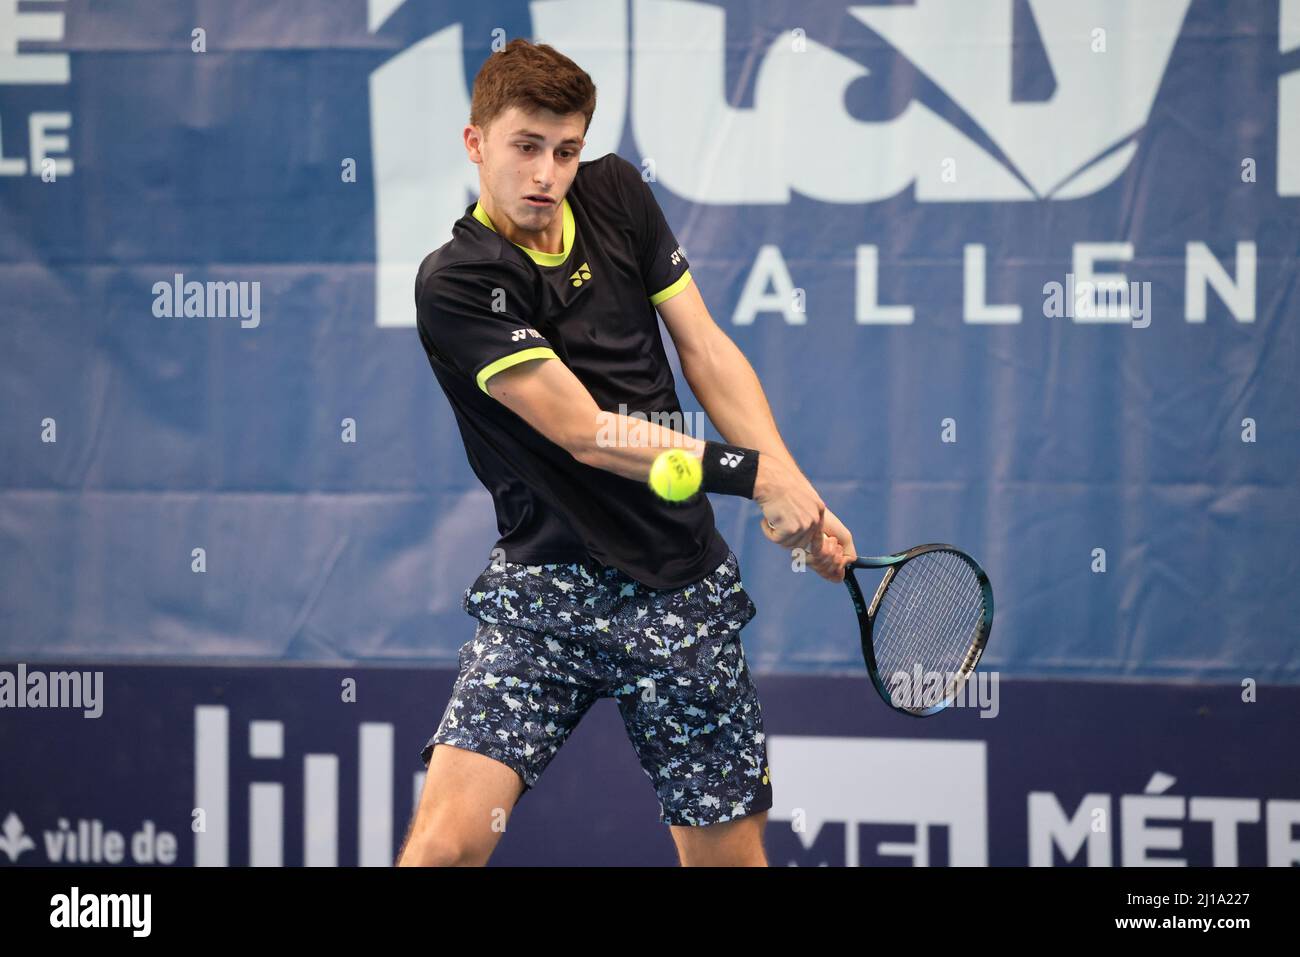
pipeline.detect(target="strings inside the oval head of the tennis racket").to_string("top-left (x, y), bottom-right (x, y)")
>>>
top-left (872, 551), bottom-right (987, 710)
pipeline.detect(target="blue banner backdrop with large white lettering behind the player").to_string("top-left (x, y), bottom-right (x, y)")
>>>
top-left (0, 0), bottom-right (1300, 686)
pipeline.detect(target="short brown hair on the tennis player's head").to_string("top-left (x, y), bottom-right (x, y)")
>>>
top-left (469, 38), bottom-right (595, 135)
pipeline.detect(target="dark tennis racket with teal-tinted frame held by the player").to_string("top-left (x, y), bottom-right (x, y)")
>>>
top-left (844, 545), bottom-right (993, 718)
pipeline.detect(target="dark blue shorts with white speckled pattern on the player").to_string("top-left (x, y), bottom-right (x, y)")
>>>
top-left (420, 553), bottom-right (772, 826)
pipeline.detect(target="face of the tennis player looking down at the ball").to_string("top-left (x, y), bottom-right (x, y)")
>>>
top-left (478, 107), bottom-right (585, 233)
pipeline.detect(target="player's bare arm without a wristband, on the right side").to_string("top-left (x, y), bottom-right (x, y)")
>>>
top-left (657, 280), bottom-right (857, 559)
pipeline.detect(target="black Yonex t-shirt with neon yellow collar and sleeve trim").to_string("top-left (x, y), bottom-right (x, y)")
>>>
top-left (415, 153), bottom-right (728, 589)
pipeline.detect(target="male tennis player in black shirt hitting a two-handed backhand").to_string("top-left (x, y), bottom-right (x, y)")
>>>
top-left (398, 39), bottom-right (854, 865)
